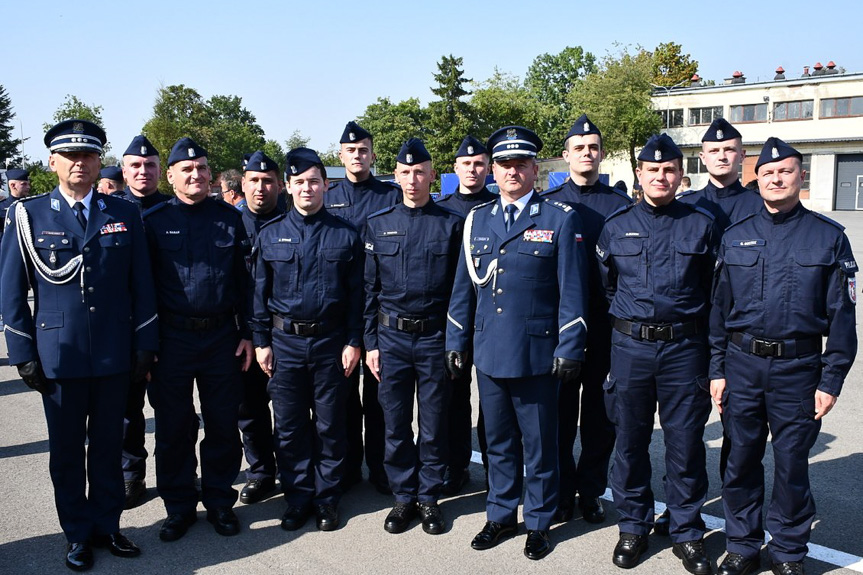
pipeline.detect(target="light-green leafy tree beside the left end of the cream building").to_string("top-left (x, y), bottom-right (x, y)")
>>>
top-left (569, 47), bottom-right (662, 180)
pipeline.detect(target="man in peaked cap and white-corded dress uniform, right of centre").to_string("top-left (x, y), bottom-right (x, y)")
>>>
top-left (446, 126), bottom-right (587, 559)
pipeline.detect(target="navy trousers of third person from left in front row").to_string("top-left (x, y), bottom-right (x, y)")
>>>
top-left (267, 332), bottom-right (349, 507)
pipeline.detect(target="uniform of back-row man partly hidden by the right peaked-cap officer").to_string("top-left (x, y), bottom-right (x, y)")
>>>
top-left (437, 187), bottom-right (497, 472)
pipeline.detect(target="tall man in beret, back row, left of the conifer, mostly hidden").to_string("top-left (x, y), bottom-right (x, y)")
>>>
top-left (324, 121), bottom-right (402, 494)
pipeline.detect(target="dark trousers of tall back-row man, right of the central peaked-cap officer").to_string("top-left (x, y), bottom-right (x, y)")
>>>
top-left (558, 322), bottom-right (614, 500)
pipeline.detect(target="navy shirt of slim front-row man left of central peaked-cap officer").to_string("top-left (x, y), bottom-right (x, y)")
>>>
top-left (365, 200), bottom-right (464, 349)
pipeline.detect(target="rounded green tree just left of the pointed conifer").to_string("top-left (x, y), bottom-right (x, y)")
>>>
top-left (357, 98), bottom-right (427, 173)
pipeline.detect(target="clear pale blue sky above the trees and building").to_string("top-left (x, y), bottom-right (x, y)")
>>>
top-left (0, 0), bottom-right (863, 165)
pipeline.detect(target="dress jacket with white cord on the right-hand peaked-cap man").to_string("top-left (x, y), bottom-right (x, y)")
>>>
top-left (446, 194), bottom-right (587, 378)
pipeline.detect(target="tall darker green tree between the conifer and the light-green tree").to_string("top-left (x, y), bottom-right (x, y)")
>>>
top-left (524, 46), bottom-right (596, 148)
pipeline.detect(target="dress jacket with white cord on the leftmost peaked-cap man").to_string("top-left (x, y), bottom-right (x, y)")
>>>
top-left (0, 188), bottom-right (158, 379)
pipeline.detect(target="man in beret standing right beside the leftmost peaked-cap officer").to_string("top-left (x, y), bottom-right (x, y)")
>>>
top-left (144, 138), bottom-right (252, 541)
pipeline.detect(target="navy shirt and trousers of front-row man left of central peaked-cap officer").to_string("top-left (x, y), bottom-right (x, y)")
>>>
top-left (364, 200), bottom-right (464, 503)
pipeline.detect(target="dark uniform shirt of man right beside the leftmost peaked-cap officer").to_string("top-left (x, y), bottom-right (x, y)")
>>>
top-left (144, 197), bottom-right (251, 339)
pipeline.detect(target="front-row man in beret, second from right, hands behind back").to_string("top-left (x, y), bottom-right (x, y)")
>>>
top-left (596, 134), bottom-right (718, 575)
